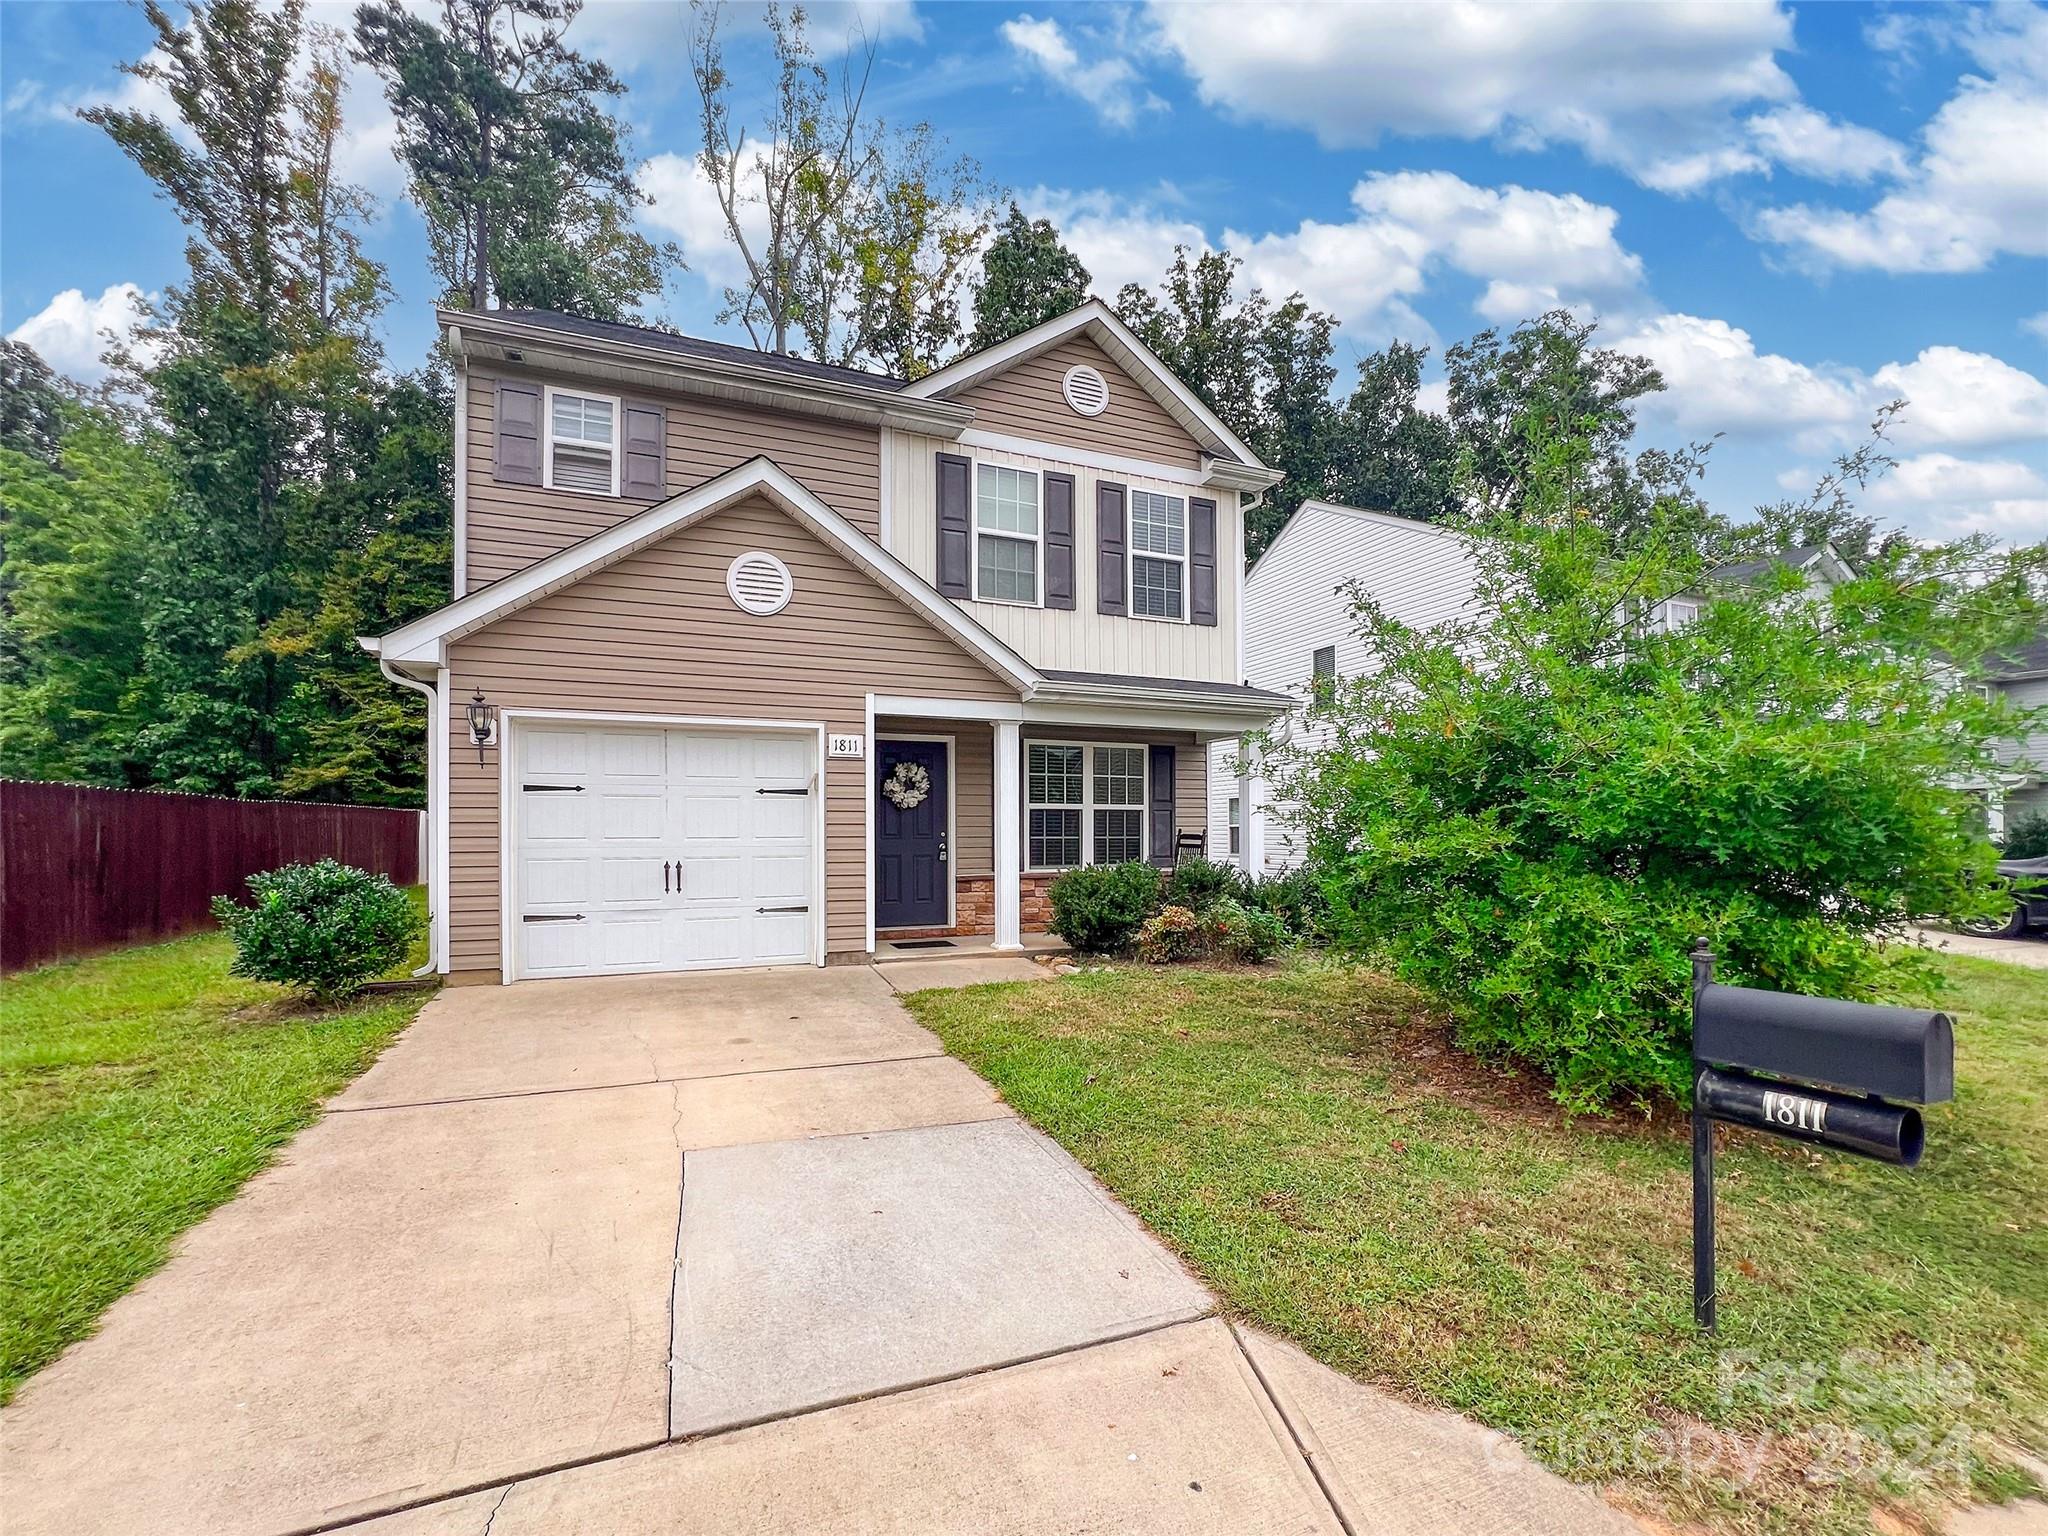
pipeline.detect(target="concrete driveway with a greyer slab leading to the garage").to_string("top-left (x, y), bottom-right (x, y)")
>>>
top-left (0, 969), bottom-right (1632, 1536)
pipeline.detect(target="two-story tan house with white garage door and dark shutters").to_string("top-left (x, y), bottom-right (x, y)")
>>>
top-left (362, 301), bottom-right (1286, 981)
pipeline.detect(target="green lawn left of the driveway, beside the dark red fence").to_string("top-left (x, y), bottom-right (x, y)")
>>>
top-left (0, 909), bottom-right (428, 1403)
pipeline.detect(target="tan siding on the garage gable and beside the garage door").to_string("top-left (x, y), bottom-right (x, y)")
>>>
top-left (446, 502), bottom-right (1018, 975)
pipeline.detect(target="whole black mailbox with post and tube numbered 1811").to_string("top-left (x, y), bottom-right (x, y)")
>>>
top-left (1692, 940), bottom-right (1956, 1333)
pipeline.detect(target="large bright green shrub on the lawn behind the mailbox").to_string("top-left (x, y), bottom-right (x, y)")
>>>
top-left (1268, 420), bottom-right (2048, 1108)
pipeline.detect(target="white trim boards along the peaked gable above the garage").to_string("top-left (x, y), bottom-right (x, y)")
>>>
top-left (377, 457), bottom-right (1040, 692)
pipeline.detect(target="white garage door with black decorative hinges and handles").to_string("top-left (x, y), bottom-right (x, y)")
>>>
top-left (512, 723), bottom-right (817, 977)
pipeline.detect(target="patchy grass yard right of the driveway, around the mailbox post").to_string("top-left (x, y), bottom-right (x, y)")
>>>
top-left (905, 958), bottom-right (2048, 1534)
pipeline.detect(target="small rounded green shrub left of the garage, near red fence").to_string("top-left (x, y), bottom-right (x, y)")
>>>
top-left (213, 858), bottom-right (426, 1001)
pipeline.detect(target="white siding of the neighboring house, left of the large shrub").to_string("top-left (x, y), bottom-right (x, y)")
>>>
top-left (1208, 504), bottom-right (1479, 870)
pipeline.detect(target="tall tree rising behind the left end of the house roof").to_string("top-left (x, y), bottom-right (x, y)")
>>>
top-left (354, 0), bottom-right (676, 319)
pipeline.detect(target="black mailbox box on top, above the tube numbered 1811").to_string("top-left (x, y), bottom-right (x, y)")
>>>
top-left (1692, 983), bottom-right (1956, 1104)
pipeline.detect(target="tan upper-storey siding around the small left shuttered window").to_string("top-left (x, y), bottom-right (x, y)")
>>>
top-left (463, 369), bottom-right (881, 592)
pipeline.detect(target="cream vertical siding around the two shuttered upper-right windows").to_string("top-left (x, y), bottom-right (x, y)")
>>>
top-left (889, 428), bottom-right (1245, 682)
